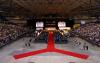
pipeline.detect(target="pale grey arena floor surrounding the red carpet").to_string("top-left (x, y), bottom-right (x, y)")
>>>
top-left (0, 37), bottom-right (100, 63)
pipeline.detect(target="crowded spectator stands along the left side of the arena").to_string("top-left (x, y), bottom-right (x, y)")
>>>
top-left (0, 23), bottom-right (26, 47)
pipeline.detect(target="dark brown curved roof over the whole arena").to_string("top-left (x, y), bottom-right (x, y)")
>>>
top-left (0, 0), bottom-right (100, 16)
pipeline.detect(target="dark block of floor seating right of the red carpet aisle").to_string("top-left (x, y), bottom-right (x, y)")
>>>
top-left (54, 31), bottom-right (67, 44)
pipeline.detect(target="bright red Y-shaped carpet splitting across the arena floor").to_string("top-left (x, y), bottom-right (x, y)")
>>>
top-left (14, 32), bottom-right (89, 59)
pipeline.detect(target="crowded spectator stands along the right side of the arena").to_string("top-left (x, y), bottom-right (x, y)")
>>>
top-left (72, 23), bottom-right (100, 46)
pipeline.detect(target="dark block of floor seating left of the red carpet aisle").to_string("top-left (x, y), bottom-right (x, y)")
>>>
top-left (34, 31), bottom-right (48, 43)
